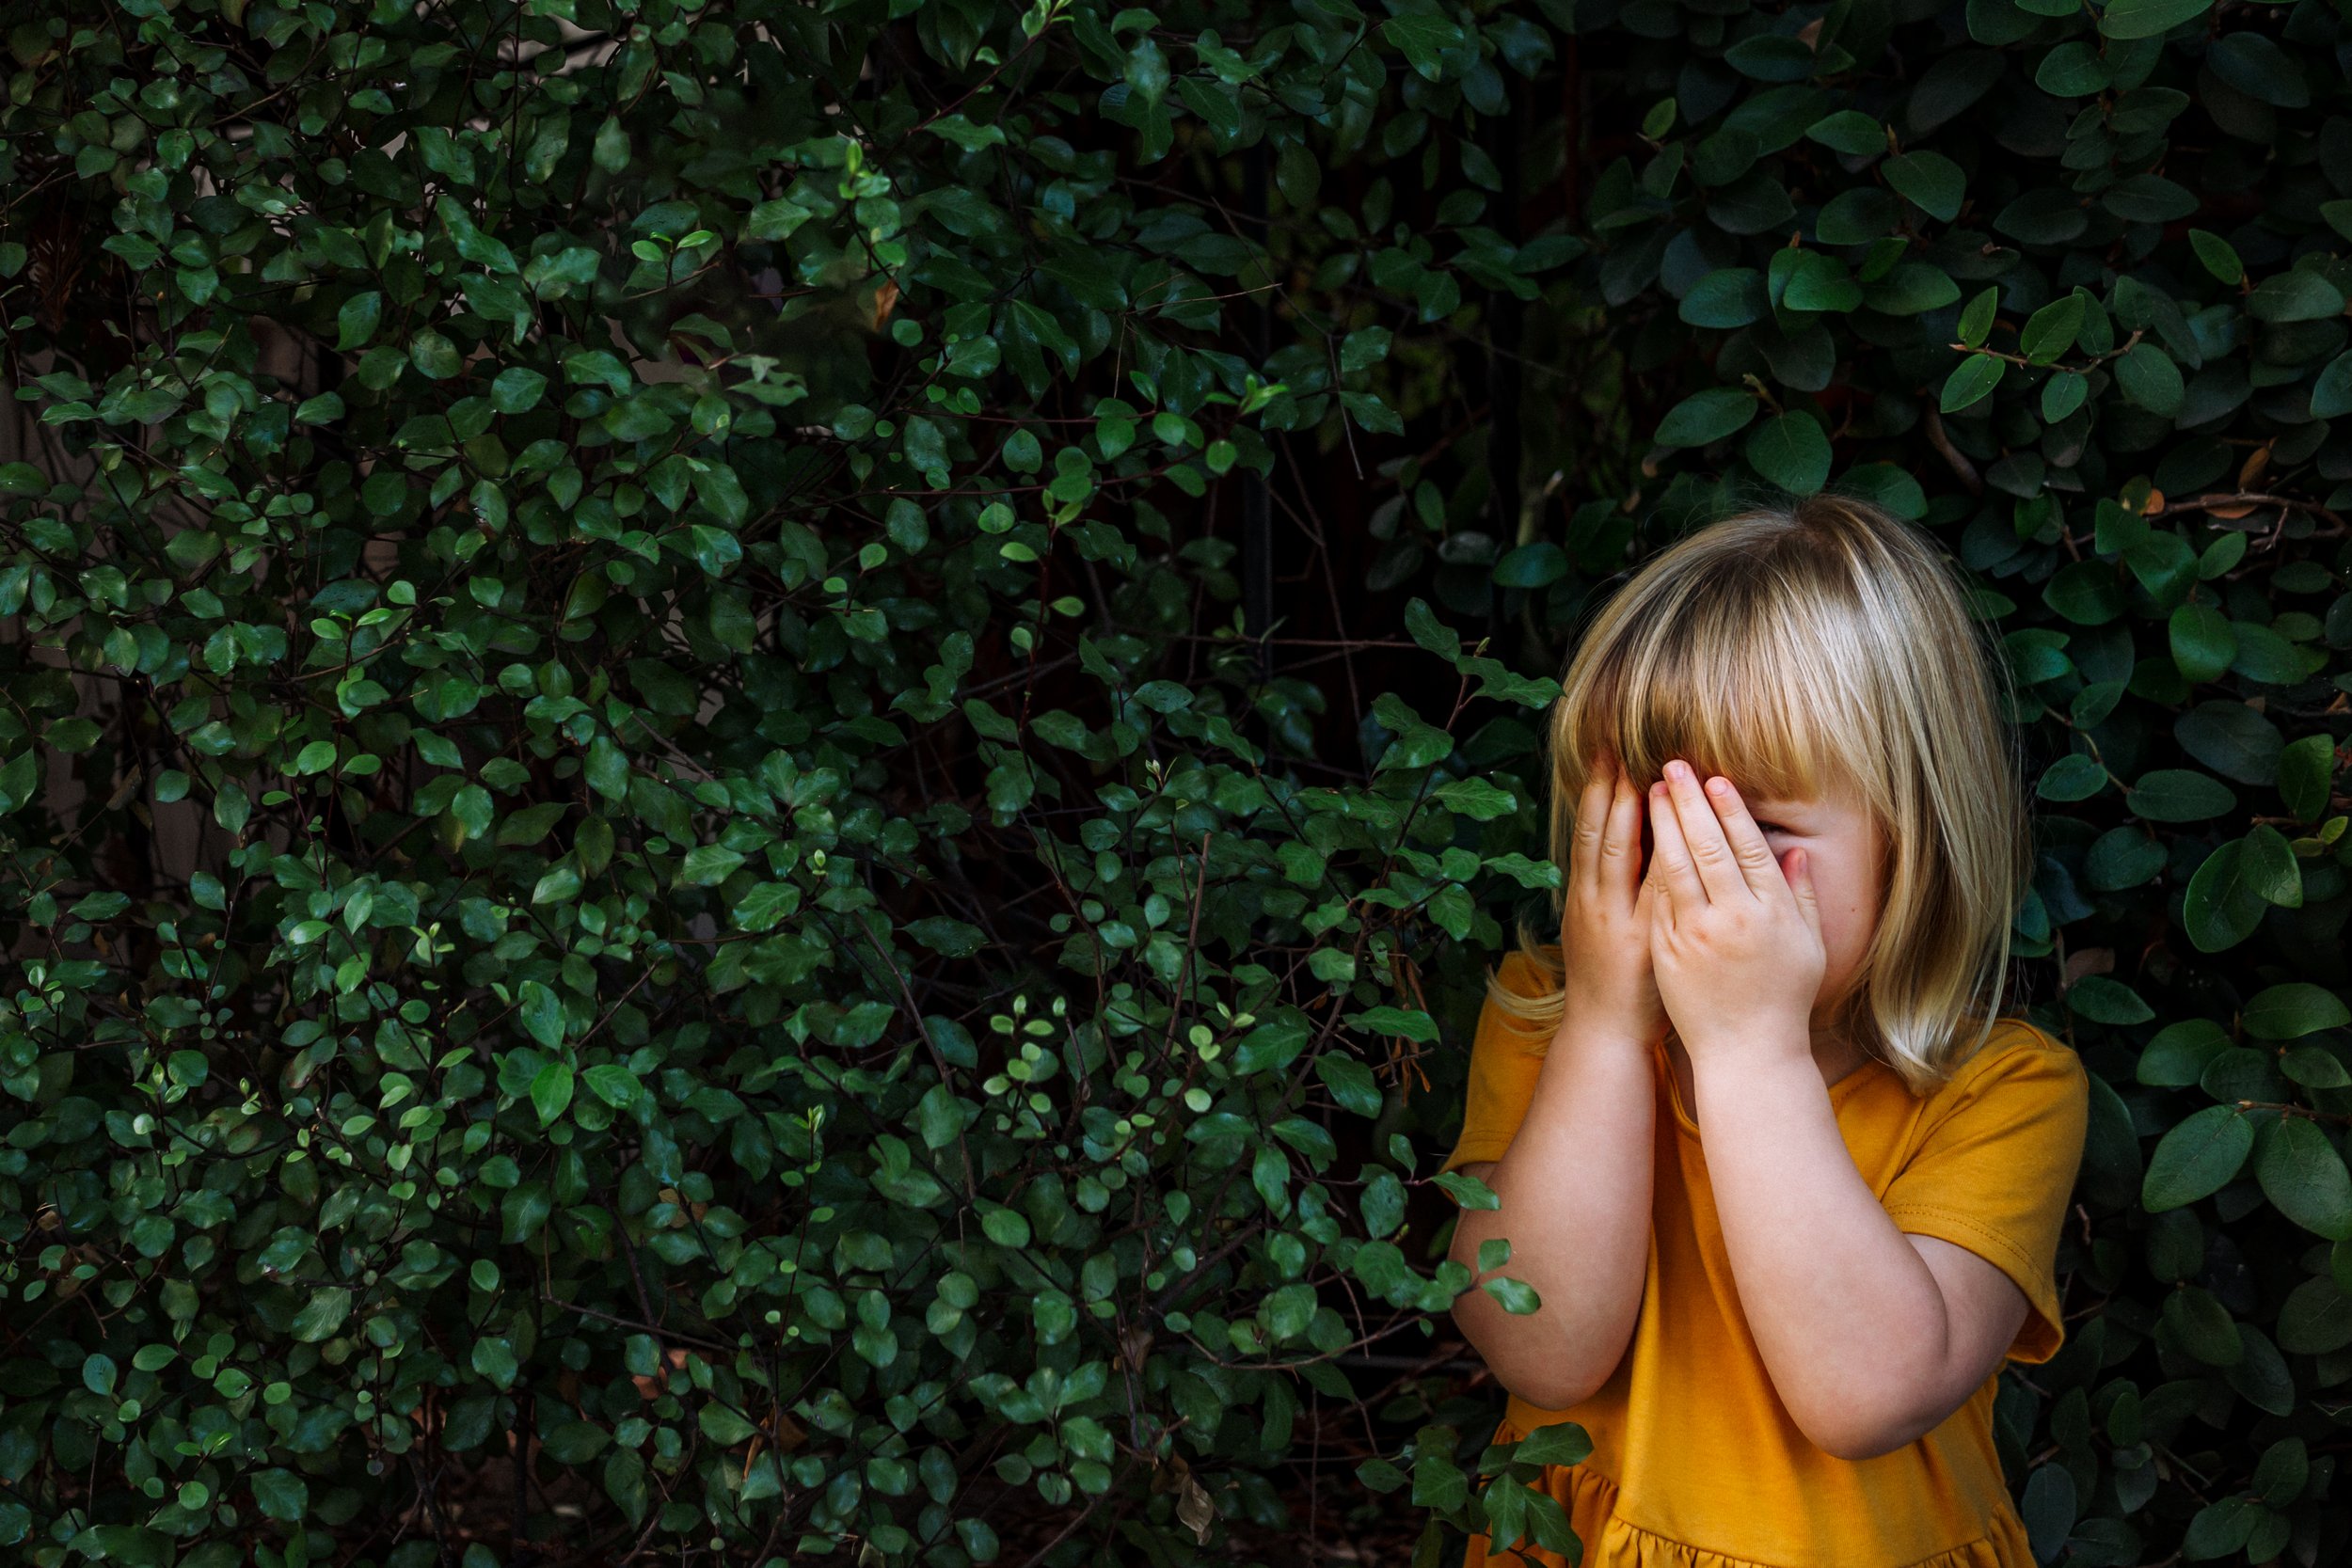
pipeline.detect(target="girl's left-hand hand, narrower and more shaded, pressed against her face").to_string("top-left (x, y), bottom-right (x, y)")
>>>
top-left (1560, 757), bottom-right (1665, 1046)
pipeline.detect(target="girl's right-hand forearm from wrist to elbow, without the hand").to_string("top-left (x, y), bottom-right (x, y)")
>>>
top-left (1696, 1039), bottom-right (1952, 1458)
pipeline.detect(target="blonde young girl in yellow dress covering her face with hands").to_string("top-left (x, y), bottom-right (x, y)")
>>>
top-left (1444, 496), bottom-right (2089, 1568)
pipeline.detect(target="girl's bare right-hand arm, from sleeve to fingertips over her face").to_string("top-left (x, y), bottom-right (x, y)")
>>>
top-left (1651, 764), bottom-right (2027, 1460)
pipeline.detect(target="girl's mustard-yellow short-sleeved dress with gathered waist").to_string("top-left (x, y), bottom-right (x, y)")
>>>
top-left (1444, 955), bottom-right (2089, 1568)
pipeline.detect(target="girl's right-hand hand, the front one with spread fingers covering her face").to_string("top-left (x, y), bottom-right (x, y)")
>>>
top-left (1649, 759), bottom-right (1828, 1065)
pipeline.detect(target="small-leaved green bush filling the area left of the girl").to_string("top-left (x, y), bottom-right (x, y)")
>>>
top-left (0, 0), bottom-right (1576, 1568)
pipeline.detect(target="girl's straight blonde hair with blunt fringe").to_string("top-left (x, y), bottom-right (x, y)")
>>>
top-left (1486, 496), bottom-right (2032, 1093)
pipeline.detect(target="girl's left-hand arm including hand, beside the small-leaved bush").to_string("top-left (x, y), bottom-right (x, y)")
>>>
top-left (1449, 767), bottom-right (1665, 1411)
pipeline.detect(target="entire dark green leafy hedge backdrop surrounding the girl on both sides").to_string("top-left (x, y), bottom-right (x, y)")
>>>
top-left (0, 0), bottom-right (2352, 1568)
